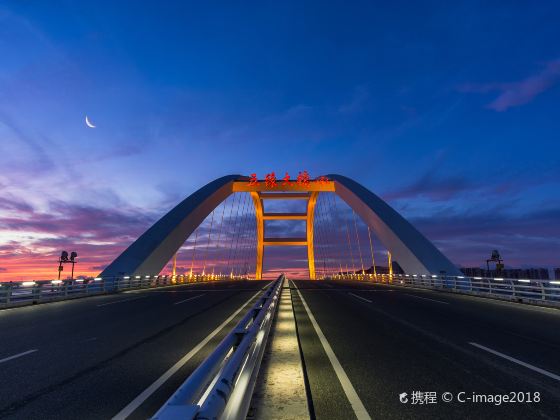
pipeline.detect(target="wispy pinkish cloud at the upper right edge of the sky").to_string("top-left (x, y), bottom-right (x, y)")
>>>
top-left (459, 59), bottom-right (560, 112)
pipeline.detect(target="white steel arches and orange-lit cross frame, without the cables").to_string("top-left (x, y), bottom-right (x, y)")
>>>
top-left (100, 174), bottom-right (461, 278)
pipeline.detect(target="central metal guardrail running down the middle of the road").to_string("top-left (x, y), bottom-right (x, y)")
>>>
top-left (152, 275), bottom-right (285, 420)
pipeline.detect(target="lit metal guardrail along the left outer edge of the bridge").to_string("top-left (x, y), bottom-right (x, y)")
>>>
top-left (0, 275), bottom-right (246, 308)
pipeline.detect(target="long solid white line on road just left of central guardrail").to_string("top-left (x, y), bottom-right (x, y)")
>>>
top-left (113, 290), bottom-right (261, 420)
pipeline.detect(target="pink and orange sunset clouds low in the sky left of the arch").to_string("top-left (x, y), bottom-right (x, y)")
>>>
top-left (0, 198), bottom-right (154, 281)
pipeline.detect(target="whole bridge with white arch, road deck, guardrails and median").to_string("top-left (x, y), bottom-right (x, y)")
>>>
top-left (0, 174), bottom-right (560, 419)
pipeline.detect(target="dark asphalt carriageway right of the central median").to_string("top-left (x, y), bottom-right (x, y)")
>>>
top-left (291, 281), bottom-right (560, 420)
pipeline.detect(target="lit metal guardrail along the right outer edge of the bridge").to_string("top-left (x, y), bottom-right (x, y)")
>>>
top-left (329, 274), bottom-right (560, 306)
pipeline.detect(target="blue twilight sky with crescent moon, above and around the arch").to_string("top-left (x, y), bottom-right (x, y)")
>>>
top-left (0, 0), bottom-right (560, 280)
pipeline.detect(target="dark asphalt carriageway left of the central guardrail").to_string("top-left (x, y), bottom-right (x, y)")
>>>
top-left (0, 281), bottom-right (269, 419)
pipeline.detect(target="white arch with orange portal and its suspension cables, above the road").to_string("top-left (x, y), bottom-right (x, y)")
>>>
top-left (100, 174), bottom-right (461, 279)
